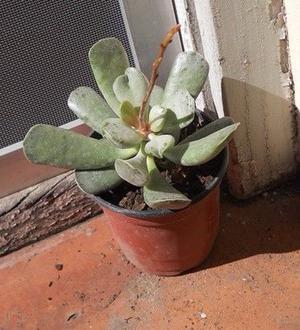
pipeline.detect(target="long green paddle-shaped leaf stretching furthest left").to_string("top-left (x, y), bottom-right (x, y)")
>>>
top-left (23, 124), bottom-right (137, 170)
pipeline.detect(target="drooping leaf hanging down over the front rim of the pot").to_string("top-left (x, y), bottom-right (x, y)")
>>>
top-left (144, 157), bottom-right (191, 210)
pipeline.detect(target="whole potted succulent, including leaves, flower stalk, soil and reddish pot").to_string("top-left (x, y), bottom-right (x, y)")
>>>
top-left (23, 25), bottom-right (238, 275)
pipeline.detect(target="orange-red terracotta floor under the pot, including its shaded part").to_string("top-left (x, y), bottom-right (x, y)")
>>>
top-left (0, 186), bottom-right (300, 330)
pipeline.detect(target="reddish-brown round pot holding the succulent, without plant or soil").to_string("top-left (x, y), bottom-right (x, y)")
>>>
top-left (94, 149), bottom-right (228, 275)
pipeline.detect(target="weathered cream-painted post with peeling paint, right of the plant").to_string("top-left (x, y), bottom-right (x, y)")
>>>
top-left (177, 0), bottom-right (300, 198)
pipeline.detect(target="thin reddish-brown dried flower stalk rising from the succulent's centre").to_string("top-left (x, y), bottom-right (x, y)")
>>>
top-left (139, 24), bottom-right (180, 132)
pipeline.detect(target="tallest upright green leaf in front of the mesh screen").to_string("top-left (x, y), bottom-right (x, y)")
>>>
top-left (89, 38), bottom-right (129, 114)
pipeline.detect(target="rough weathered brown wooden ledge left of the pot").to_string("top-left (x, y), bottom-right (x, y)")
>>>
top-left (0, 172), bottom-right (101, 256)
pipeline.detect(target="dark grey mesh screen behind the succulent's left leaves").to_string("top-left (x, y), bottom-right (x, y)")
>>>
top-left (0, 0), bottom-right (134, 148)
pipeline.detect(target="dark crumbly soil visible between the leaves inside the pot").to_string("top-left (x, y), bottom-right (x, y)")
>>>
top-left (101, 112), bottom-right (222, 211)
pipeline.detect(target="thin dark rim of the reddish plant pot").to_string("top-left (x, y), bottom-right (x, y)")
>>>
top-left (90, 147), bottom-right (229, 218)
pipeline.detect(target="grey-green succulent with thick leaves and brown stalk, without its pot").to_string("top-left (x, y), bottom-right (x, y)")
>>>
top-left (23, 26), bottom-right (238, 209)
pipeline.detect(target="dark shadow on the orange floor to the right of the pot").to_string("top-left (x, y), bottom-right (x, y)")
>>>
top-left (188, 180), bottom-right (300, 272)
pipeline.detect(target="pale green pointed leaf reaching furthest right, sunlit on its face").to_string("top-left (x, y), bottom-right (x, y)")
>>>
top-left (164, 123), bottom-right (239, 166)
